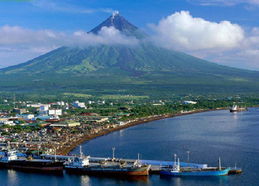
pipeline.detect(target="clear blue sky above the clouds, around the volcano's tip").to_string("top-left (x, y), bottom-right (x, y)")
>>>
top-left (0, 0), bottom-right (259, 31)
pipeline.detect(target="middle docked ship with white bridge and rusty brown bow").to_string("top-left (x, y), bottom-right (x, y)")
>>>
top-left (65, 148), bottom-right (151, 176)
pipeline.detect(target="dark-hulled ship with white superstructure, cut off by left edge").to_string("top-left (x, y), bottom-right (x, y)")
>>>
top-left (0, 150), bottom-right (63, 172)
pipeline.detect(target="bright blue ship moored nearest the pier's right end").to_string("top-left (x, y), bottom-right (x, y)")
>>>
top-left (160, 158), bottom-right (230, 177)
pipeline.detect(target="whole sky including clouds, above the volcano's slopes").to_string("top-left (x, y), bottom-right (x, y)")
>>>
top-left (0, 0), bottom-right (259, 70)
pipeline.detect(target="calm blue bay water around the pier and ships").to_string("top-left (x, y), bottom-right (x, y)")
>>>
top-left (0, 108), bottom-right (259, 186)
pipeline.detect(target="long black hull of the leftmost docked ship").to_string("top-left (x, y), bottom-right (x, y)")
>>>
top-left (0, 160), bottom-right (63, 172)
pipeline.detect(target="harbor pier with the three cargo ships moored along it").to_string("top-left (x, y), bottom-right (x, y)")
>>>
top-left (0, 146), bottom-right (242, 177)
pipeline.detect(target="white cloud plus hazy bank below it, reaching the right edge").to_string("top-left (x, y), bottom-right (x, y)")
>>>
top-left (151, 11), bottom-right (259, 70)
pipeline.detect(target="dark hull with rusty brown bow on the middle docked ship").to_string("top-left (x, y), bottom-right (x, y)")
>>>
top-left (65, 166), bottom-right (150, 176)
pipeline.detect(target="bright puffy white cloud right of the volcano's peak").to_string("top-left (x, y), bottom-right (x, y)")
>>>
top-left (152, 11), bottom-right (244, 51)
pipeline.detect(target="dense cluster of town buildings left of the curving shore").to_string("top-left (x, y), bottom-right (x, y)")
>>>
top-left (0, 101), bottom-right (130, 154)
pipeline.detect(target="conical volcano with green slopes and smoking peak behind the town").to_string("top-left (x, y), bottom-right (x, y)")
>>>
top-left (0, 12), bottom-right (259, 94)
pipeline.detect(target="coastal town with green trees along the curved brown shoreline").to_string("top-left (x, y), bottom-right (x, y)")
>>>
top-left (0, 93), bottom-right (254, 155)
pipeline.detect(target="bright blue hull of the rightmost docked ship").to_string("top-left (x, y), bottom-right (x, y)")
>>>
top-left (160, 169), bottom-right (230, 177)
